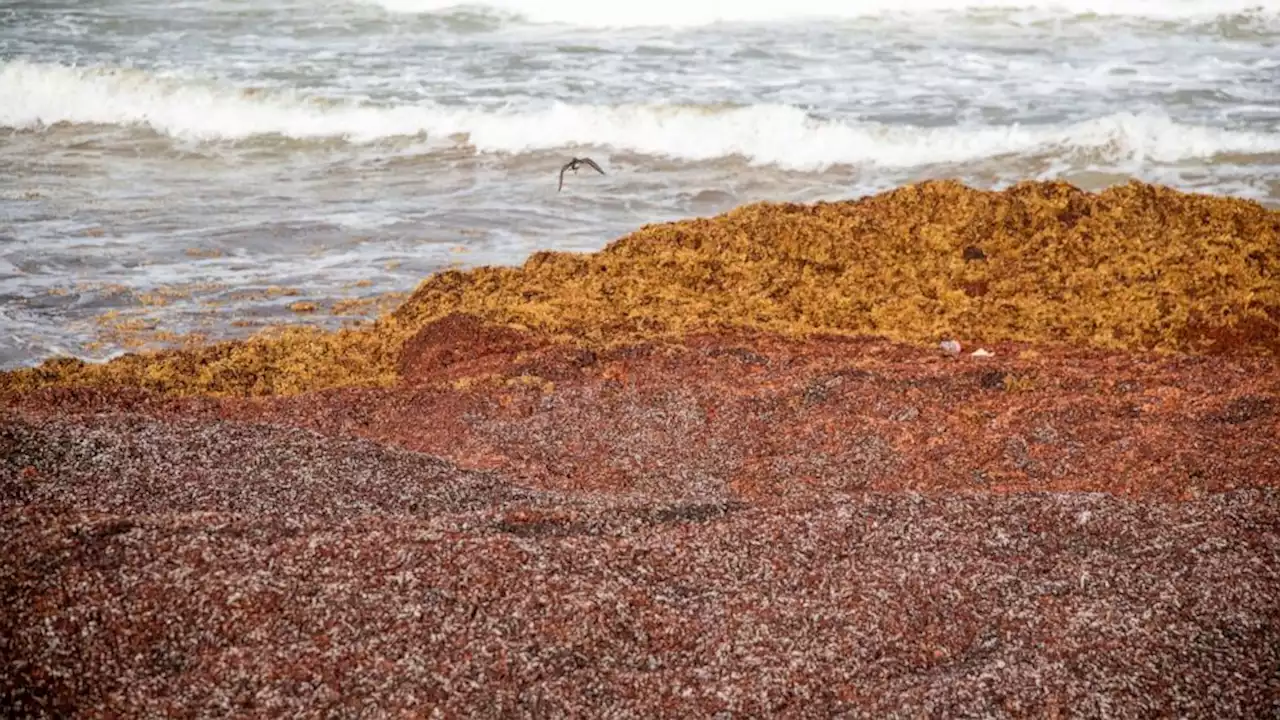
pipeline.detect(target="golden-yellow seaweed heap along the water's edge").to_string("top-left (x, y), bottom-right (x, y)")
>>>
top-left (0, 181), bottom-right (1280, 396)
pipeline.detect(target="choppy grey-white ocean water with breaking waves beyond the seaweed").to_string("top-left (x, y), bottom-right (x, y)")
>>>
top-left (0, 0), bottom-right (1280, 368)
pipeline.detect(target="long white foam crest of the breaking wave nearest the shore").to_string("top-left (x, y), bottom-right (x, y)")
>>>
top-left (0, 61), bottom-right (1280, 170)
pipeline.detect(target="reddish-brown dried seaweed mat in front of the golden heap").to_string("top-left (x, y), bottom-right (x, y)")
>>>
top-left (0, 318), bottom-right (1280, 717)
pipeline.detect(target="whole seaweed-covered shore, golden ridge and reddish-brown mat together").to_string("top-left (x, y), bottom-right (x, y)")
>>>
top-left (0, 183), bottom-right (1280, 717)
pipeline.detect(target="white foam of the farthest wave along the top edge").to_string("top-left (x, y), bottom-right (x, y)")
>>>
top-left (356, 0), bottom-right (1280, 27)
